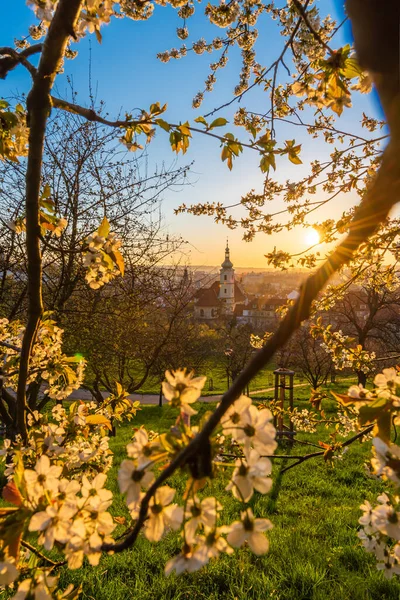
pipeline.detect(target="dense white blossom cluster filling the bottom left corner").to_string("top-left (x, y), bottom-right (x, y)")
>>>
top-left (0, 388), bottom-right (138, 600)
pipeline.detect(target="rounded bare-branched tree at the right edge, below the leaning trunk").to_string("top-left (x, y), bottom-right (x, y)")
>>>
top-left (314, 259), bottom-right (400, 386)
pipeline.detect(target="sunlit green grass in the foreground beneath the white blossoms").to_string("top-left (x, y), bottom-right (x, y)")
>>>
top-left (35, 401), bottom-right (400, 600)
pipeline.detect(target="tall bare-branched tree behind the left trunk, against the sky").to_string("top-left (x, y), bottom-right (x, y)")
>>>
top-left (0, 95), bottom-right (188, 321)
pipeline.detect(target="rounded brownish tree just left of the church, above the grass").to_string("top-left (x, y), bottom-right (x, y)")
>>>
top-left (66, 265), bottom-right (193, 400)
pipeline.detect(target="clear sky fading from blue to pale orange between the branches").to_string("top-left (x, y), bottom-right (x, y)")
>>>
top-left (0, 0), bottom-right (384, 267)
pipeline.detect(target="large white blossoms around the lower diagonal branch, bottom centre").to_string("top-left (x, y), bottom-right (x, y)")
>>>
top-left (118, 370), bottom-right (276, 574)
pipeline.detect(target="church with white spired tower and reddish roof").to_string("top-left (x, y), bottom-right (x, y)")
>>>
top-left (194, 240), bottom-right (246, 320)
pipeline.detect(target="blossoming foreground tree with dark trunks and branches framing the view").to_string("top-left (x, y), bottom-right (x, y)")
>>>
top-left (0, 0), bottom-right (400, 599)
